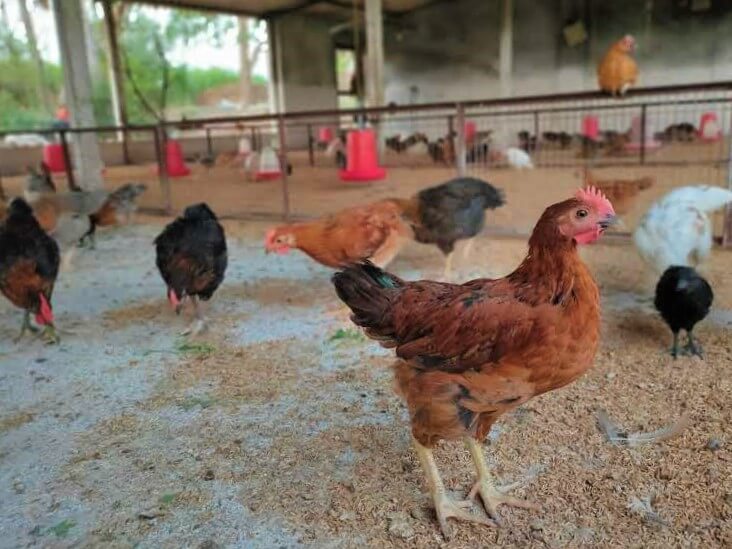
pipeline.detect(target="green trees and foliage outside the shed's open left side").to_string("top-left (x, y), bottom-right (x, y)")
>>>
top-left (0, 4), bottom-right (266, 129)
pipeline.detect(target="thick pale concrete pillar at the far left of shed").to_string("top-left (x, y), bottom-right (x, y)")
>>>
top-left (52, 0), bottom-right (103, 190)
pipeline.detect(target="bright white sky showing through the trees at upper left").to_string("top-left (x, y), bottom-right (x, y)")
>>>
top-left (0, 0), bottom-right (260, 74)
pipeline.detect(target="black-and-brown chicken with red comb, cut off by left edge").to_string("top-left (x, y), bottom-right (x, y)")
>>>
top-left (0, 198), bottom-right (60, 343)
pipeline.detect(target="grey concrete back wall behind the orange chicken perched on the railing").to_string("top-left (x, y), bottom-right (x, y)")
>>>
top-left (385, 0), bottom-right (732, 104)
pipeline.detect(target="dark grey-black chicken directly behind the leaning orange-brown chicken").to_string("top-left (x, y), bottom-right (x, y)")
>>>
top-left (403, 177), bottom-right (505, 278)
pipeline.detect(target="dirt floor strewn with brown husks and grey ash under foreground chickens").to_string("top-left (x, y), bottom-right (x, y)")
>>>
top-left (0, 209), bottom-right (732, 548)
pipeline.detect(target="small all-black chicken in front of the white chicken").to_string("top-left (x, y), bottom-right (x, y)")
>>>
top-left (654, 266), bottom-right (714, 358)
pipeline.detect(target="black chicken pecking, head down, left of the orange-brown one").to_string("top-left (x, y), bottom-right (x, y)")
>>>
top-left (155, 203), bottom-right (228, 335)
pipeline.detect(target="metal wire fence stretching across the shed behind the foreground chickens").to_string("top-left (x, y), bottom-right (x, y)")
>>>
top-left (0, 82), bottom-right (732, 243)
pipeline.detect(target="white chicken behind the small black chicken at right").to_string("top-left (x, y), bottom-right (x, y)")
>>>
top-left (633, 185), bottom-right (732, 274)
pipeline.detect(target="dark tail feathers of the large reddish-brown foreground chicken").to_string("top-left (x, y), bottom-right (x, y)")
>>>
top-left (331, 262), bottom-right (404, 331)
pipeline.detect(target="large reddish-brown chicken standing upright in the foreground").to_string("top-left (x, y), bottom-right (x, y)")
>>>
top-left (333, 188), bottom-right (615, 537)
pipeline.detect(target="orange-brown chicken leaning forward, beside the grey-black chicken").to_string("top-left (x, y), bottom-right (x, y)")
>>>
top-left (264, 199), bottom-right (412, 268)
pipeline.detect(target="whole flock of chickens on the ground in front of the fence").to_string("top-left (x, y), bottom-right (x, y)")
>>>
top-left (0, 155), bottom-right (732, 537)
